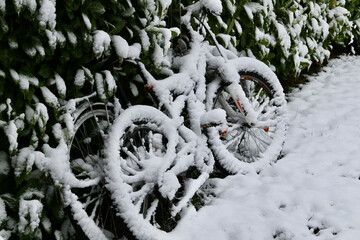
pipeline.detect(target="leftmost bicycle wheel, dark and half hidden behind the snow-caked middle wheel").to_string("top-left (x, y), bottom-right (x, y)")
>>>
top-left (63, 103), bottom-right (129, 239)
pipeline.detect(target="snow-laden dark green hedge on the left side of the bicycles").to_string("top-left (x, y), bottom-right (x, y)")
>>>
top-left (0, 0), bottom-right (174, 239)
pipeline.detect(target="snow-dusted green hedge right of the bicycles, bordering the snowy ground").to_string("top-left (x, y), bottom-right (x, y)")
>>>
top-left (212, 0), bottom-right (360, 84)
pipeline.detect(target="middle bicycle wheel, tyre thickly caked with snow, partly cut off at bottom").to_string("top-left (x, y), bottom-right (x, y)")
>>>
top-left (105, 105), bottom-right (188, 240)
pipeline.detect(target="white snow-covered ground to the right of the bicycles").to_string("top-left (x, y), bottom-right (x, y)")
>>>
top-left (171, 56), bottom-right (360, 240)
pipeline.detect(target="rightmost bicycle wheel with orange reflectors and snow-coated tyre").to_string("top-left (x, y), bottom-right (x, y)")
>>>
top-left (207, 70), bottom-right (286, 173)
